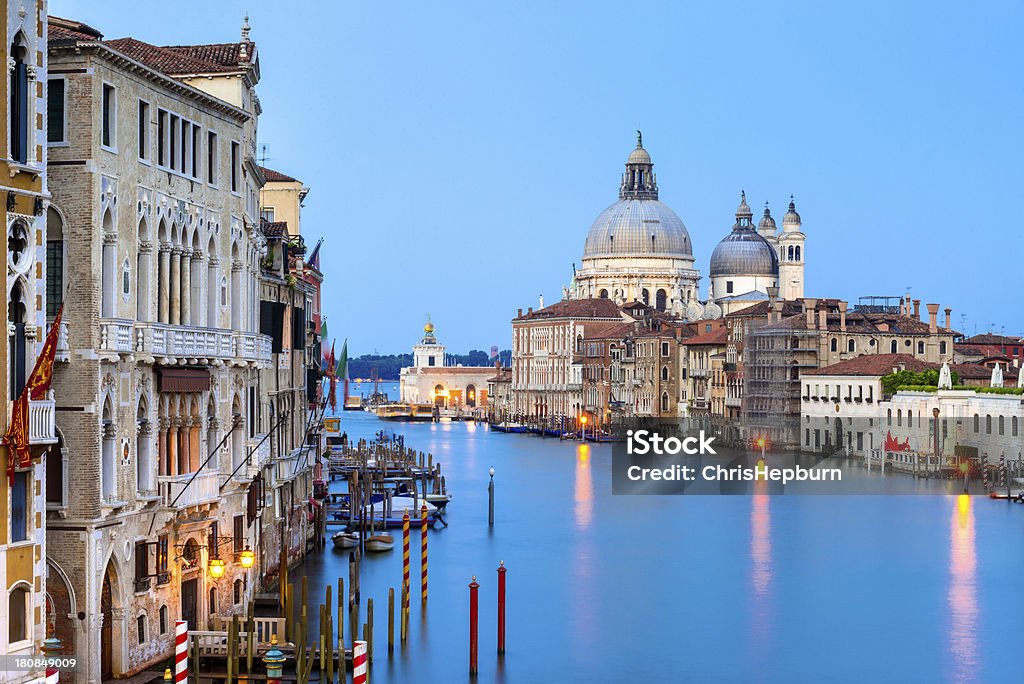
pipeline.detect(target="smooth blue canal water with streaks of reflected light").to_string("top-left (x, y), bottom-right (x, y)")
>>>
top-left (292, 389), bottom-right (1024, 683)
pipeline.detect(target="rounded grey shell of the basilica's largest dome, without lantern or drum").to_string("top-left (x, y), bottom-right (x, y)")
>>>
top-left (583, 200), bottom-right (693, 259)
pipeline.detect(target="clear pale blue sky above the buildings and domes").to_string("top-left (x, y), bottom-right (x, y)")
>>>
top-left (50, 0), bottom-right (1024, 355)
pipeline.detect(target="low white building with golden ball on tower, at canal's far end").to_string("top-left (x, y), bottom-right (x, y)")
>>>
top-left (398, 320), bottom-right (495, 413)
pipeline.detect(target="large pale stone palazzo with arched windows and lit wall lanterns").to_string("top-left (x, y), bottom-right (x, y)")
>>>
top-left (46, 17), bottom-right (271, 682)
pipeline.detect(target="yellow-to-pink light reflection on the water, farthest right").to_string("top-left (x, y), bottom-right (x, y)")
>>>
top-left (948, 495), bottom-right (978, 682)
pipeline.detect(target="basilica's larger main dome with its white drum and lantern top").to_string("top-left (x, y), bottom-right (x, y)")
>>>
top-left (565, 131), bottom-right (702, 317)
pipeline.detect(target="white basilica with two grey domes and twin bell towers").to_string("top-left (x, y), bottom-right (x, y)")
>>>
top-left (564, 131), bottom-right (806, 319)
